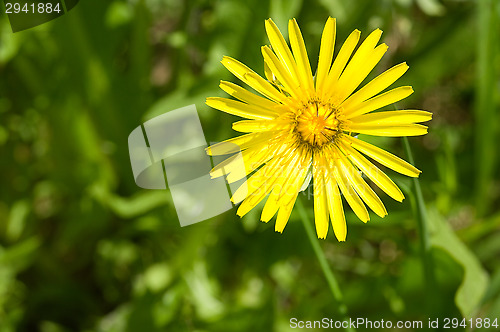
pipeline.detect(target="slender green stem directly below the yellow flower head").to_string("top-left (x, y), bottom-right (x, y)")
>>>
top-left (297, 197), bottom-right (355, 331)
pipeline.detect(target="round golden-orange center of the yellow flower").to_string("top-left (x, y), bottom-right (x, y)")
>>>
top-left (296, 101), bottom-right (340, 147)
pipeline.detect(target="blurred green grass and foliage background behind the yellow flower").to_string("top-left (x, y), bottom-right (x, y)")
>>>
top-left (0, 0), bottom-right (500, 332)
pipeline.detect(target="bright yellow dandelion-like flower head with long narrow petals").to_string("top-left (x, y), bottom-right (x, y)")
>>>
top-left (206, 17), bottom-right (432, 241)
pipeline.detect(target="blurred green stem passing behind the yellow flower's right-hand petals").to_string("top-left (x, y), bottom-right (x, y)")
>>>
top-left (403, 137), bottom-right (436, 302)
